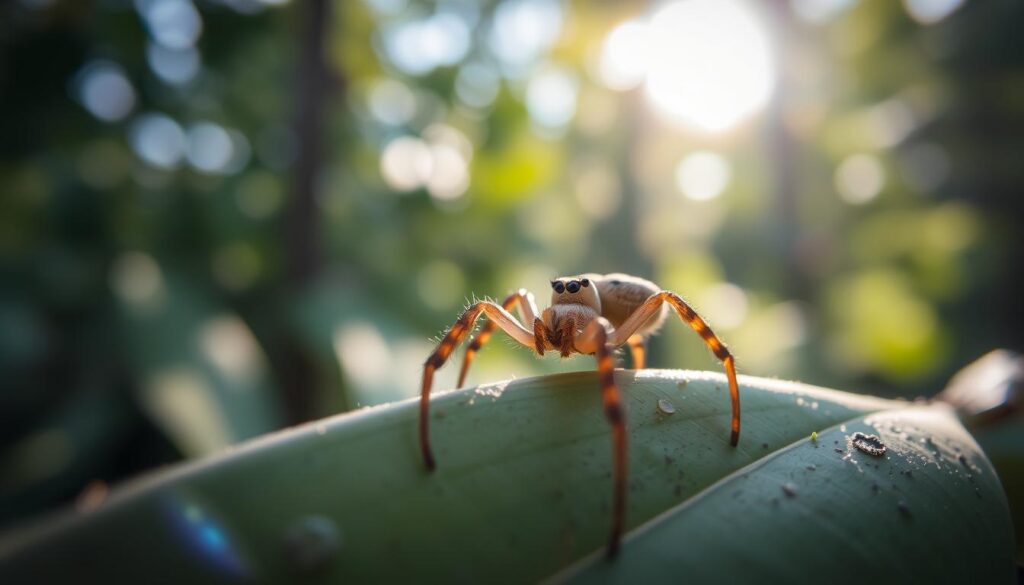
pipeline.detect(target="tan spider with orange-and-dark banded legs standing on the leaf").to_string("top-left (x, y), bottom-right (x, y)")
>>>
top-left (420, 274), bottom-right (739, 557)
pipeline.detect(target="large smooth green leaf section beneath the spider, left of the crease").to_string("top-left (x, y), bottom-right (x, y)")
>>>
top-left (0, 371), bottom-right (995, 582)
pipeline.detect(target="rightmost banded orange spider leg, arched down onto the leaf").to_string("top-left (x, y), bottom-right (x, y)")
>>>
top-left (611, 291), bottom-right (739, 447)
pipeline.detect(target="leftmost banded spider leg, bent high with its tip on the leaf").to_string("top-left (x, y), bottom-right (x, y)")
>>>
top-left (420, 300), bottom-right (534, 471)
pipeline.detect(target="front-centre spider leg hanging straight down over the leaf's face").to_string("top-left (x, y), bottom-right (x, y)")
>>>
top-left (577, 317), bottom-right (627, 558)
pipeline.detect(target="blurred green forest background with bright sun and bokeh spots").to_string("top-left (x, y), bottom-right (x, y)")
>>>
top-left (0, 0), bottom-right (1024, 526)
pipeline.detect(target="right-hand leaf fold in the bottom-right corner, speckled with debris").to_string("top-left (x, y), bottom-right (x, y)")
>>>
top-left (562, 407), bottom-right (1015, 583)
